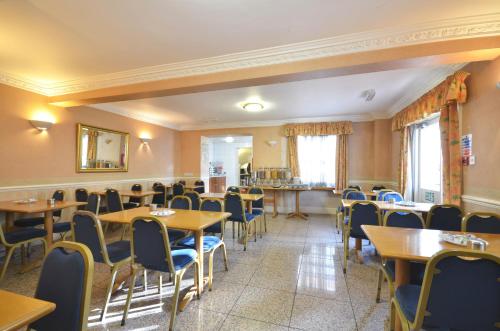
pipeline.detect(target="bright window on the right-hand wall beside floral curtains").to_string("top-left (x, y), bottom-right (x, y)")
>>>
top-left (411, 118), bottom-right (442, 203)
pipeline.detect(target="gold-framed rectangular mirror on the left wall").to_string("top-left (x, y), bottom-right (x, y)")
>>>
top-left (76, 123), bottom-right (129, 172)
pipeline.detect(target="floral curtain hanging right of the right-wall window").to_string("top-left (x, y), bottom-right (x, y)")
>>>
top-left (439, 101), bottom-right (462, 206)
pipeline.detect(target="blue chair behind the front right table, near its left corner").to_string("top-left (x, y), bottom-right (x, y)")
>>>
top-left (375, 210), bottom-right (425, 302)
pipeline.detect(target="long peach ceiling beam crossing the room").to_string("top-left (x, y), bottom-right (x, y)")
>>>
top-left (49, 36), bottom-right (500, 107)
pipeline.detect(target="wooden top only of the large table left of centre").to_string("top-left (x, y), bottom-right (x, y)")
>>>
top-left (99, 207), bottom-right (231, 231)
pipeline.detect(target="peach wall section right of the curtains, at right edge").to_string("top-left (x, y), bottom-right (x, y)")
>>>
top-left (462, 57), bottom-right (500, 201)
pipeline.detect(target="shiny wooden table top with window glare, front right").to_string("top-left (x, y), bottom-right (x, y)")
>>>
top-left (361, 225), bottom-right (500, 261)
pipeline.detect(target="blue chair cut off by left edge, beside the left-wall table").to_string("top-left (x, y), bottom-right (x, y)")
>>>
top-left (0, 226), bottom-right (47, 281)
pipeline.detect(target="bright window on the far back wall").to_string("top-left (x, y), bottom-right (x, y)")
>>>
top-left (297, 136), bottom-right (337, 187)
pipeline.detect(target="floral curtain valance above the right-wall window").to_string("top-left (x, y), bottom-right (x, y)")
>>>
top-left (392, 71), bottom-right (469, 131)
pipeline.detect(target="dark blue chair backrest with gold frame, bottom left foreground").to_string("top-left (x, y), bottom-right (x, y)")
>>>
top-left (28, 241), bottom-right (94, 331)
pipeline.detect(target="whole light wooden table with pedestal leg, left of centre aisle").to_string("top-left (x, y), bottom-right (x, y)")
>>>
top-left (99, 207), bottom-right (231, 311)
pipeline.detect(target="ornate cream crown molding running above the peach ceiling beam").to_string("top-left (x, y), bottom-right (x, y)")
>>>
top-left (0, 13), bottom-right (500, 96)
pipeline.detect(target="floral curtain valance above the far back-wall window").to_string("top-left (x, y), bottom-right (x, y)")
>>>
top-left (282, 121), bottom-right (353, 137)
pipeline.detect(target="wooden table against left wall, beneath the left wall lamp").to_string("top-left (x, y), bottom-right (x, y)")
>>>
top-left (0, 200), bottom-right (87, 246)
